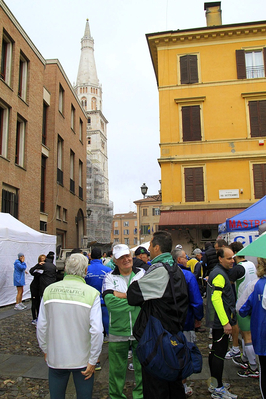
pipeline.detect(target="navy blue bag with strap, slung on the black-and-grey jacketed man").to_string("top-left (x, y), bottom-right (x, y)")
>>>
top-left (136, 264), bottom-right (202, 381)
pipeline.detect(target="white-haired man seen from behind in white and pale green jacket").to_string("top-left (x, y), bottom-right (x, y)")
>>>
top-left (37, 254), bottom-right (103, 399)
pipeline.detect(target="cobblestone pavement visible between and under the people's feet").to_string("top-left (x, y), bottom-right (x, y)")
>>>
top-left (0, 302), bottom-right (261, 399)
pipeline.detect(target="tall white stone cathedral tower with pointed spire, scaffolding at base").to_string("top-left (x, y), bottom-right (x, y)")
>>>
top-left (75, 19), bottom-right (112, 243)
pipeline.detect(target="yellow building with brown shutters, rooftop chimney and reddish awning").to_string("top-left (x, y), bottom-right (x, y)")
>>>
top-left (146, 2), bottom-right (266, 251)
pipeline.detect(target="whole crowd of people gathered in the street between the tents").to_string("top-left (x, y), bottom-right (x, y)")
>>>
top-left (14, 231), bottom-right (266, 399)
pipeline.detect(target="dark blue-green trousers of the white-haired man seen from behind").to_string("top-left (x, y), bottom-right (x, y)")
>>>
top-left (49, 367), bottom-right (94, 399)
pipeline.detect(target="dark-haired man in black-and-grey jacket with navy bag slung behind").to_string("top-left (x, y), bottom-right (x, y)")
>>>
top-left (127, 231), bottom-right (188, 399)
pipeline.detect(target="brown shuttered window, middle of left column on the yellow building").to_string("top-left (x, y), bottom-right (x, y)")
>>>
top-left (182, 105), bottom-right (201, 141)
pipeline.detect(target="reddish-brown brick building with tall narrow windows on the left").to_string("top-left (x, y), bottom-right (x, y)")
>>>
top-left (0, 1), bottom-right (87, 248)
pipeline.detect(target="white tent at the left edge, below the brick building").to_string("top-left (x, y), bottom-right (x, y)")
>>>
top-left (0, 212), bottom-right (56, 306)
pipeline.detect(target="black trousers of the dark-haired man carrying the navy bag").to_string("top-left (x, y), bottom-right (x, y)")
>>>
top-left (142, 367), bottom-right (186, 399)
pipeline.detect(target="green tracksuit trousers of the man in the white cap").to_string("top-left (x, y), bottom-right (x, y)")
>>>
top-left (108, 341), bottom-right (143, 399)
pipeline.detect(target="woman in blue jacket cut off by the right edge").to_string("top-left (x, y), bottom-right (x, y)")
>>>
top-left (237, 258), bottom-right (266, 398)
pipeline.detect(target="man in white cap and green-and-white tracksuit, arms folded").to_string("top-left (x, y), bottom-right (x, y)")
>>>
top-left (102, 244), bottom-right (145, 399)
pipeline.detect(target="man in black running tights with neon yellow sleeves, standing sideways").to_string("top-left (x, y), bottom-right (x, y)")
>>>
top-left (206, 247), bottom-right (237, 399)
